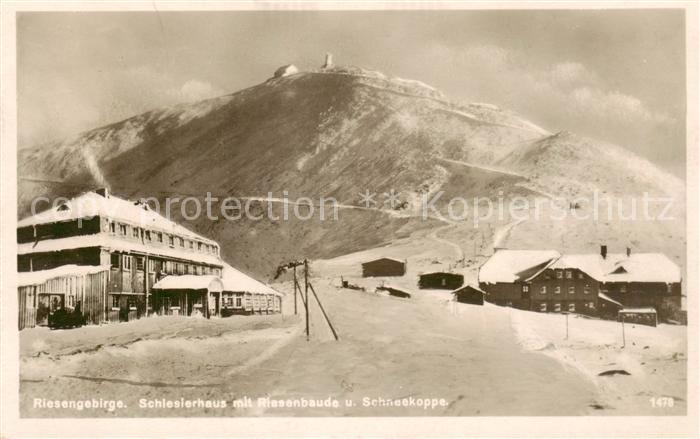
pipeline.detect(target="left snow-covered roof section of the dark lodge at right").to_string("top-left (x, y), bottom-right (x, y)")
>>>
top-left (479, 249), bottom-right (559, 283)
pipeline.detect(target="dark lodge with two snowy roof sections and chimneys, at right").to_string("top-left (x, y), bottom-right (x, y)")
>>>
top-left (479, 246), bottom-right (682, 320)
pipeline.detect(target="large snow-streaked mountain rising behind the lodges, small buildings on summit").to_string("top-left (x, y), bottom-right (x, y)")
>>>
top-left (18, 67), bottom-right (685, 275)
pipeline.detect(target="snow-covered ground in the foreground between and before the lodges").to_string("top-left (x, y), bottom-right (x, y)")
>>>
top-left (20, 253), bottom-right (686, 417)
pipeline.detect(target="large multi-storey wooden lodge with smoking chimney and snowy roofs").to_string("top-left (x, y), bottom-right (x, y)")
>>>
top-left (17, 189), bottom-right (281, 328)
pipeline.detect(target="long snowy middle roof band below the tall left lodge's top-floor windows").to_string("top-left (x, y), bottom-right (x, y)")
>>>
top-left (17, 234), bottom-right (223, 266)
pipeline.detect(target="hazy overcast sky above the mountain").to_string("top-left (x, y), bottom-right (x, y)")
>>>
top-left (17, 9), bottom-right (685, 176)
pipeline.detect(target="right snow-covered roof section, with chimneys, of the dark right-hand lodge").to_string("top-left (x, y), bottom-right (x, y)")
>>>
top-left (549, 253), bottom-right (681, 283)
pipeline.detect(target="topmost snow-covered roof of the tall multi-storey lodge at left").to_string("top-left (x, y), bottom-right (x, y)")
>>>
top-left (17, 192), bottom-right (216, 244)
